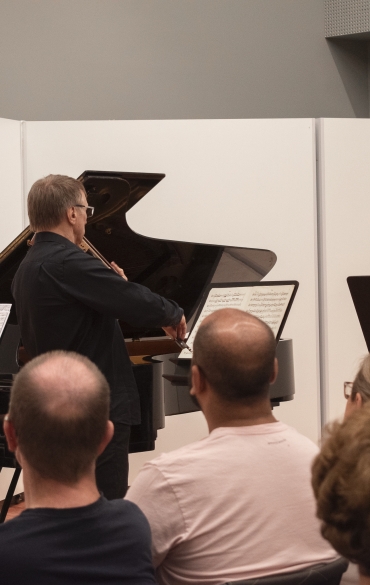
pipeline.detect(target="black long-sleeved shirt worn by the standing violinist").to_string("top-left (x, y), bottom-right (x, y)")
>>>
top-left (12, 232), bottom-right (183, 425)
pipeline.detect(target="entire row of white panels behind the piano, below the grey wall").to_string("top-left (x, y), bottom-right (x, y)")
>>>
top-left (4, 119), bottom-right (370, 486)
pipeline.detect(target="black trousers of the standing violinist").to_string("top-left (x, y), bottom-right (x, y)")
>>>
top-left (95, 423), bottom-right (131, 500)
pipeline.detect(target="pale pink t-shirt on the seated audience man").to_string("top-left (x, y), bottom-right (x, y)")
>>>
top-left (126, 422), bottom-right (337, 585)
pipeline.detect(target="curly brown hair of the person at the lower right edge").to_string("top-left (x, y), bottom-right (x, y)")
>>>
top-left (312, 405), bottom-right (370, 576)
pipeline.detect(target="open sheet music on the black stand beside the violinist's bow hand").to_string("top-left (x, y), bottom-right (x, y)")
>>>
top-left (179, 284), bottom-right (294, 359)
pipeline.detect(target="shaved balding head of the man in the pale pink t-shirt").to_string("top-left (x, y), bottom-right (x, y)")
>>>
top-left (193, 309), bottom-right (276, 402)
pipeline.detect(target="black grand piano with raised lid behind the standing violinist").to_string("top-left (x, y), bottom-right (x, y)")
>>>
top-left (0, 171), bottom-right (294, 456)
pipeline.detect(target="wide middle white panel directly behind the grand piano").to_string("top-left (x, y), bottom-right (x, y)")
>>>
top-left (21, 119), bottom-right (319, 479)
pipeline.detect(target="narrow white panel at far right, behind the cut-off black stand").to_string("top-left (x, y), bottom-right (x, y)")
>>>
top-left (319, 119), bottom-right (370, 420)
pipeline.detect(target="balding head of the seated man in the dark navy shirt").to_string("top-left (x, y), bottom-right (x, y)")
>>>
top-left (9, 351), bottom-right (109, 483)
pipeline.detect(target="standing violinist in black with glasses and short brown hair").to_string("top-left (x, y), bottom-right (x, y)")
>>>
top-left (12, 175), bottom-right (186, 499)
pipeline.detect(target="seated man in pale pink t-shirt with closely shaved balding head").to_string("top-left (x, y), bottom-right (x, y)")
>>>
top-left (127, 309), bottom-right (336, 585)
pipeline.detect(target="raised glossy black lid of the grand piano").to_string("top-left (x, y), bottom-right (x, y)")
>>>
top-left (0, 171), bottom-right (276, 339)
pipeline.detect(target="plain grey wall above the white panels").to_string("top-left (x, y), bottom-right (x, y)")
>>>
top-left (0, 0), bottom-right (369, 120)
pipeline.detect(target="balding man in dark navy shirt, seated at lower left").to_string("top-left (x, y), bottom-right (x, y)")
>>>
top-left (0, 351), bottom-right (155, 585)
